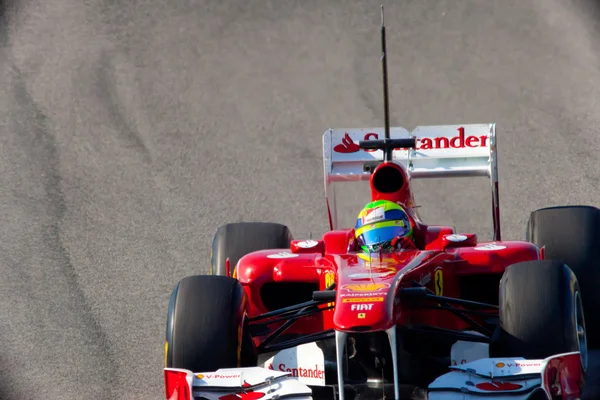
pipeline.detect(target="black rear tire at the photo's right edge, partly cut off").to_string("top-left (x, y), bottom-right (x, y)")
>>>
top-left (527, 206), bottom-right (600, 348)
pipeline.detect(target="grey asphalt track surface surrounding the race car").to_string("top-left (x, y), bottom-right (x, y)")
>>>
top-left (0, 0), bottom-right (600, 399)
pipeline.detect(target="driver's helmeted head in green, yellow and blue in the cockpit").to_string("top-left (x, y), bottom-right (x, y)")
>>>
top-left (354, 200), bottom-right (412, 252)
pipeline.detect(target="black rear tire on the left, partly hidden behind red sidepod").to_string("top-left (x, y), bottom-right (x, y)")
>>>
top-left (210, 222), bottom-right (292, 276)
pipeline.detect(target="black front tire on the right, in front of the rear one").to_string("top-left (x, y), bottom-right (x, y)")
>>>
top-left (490, 260), bottom-right (588, 370)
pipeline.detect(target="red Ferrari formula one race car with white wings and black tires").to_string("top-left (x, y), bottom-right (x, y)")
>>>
top-left (165, 124), bottom-right (600, 400)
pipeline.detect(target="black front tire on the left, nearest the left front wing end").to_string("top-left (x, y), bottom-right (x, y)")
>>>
top-left (165, 275), bottom-right (254, 372)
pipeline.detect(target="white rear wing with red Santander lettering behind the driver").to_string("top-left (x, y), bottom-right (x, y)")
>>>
top-left (323, 124), bottom-right (501, 240)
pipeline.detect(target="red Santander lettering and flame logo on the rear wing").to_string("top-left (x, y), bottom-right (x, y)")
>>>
top-left (333, 127), bottom-right (488, 153)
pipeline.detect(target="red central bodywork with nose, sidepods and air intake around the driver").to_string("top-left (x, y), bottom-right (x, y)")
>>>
top-left (235, 163), bottom-right (541, 343)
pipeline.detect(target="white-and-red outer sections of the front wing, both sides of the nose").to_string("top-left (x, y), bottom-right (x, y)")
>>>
top-left (164, 352), bottom-right (584, 400)
